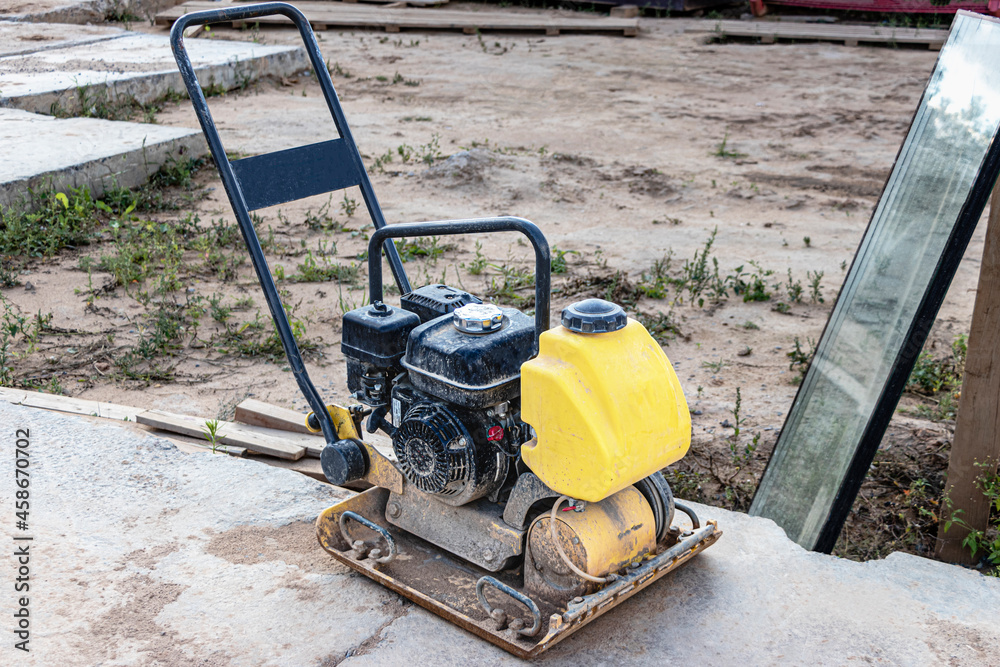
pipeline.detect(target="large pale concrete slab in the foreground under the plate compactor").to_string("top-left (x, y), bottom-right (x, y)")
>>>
top-left (0, 402), bottom-right (1000, 667)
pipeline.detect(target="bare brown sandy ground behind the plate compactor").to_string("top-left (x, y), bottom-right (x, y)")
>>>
top-left (4, 14), bottom-right (984, 552)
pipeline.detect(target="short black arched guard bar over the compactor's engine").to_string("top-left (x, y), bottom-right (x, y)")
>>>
top-left (368, 216), bottom-right (552, 354)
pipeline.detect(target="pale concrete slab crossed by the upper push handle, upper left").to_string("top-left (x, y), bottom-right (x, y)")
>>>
top-left (0, 33), bottom-right (307, 113)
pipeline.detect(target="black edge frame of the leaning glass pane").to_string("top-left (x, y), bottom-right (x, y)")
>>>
top-left (751, 13), bottom-right (1000, 553)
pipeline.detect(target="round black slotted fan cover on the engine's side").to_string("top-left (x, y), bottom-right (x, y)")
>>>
top-left (392, 401), bottom-right (507, 505)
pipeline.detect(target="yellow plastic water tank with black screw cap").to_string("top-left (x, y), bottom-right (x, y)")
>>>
top-left (521, 299), bottom-right (691, 502)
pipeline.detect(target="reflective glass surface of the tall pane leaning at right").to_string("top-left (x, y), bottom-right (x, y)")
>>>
top-left (750, 12), bottom-right (1000, 548)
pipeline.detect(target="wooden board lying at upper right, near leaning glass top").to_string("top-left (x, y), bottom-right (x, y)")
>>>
top-left (685, 21), bottom-right (948, 49)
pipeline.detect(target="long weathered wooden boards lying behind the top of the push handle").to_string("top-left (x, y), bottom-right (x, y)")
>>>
top-left (156, 0), bottom-right (639, 37)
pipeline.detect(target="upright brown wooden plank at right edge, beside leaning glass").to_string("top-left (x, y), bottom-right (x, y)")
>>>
top-left (937, 188), bottom-right (1000, 565)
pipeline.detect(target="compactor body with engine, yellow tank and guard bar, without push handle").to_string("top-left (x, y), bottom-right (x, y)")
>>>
top-left (311, 219), bottom-right (712, 636)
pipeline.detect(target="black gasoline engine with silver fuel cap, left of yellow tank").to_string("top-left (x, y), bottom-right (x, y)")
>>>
top-left (341, 285), bottom-right (534, 505)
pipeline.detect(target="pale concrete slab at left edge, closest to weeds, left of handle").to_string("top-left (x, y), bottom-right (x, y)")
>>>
top-left (0, 109), bottom-right (207, 207)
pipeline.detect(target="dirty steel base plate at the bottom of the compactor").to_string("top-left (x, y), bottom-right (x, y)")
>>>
top-left (316, 487), bottom-right (722, 658)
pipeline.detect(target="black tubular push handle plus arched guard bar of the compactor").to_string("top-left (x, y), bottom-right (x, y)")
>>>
top-left (170, 2), bottom-right (551, 460)
